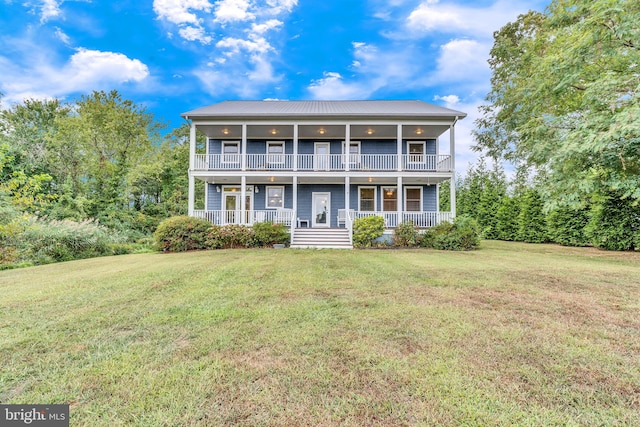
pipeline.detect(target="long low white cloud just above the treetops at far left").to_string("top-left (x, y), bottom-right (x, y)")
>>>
top-left (0, 49), bottom-right (149, 103)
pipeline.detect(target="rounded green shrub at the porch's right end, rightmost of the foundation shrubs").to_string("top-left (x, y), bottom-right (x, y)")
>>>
top-left (420, 216), bottom-right (480, 251)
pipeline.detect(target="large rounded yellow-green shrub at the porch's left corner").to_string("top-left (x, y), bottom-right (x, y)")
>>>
top-left (154, 216), bottom-right (212, 252)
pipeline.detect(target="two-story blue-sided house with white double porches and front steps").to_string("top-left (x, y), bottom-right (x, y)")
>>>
top-left (182, 101), bottom-right (466, 247)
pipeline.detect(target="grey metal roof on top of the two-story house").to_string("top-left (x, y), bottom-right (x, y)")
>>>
top-left (182, 100), bottom-right (466, 120)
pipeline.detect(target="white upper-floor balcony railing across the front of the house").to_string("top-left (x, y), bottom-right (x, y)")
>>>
top-left (194, 154), bottom-right (451, 172)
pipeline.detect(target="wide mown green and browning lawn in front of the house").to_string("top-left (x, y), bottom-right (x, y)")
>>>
top-left (0, 242), bottom-right (640, 426)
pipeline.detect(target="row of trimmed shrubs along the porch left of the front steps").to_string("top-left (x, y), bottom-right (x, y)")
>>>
top-left (154, 216), bottom-right (289, 252)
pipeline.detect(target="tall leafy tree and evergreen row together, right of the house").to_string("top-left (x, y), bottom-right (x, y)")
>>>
top-left (458, 0), bottom-right (640, 250)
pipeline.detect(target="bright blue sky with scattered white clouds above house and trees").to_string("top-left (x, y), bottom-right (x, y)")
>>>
top-left (0, 0), bottom-right (548, 171)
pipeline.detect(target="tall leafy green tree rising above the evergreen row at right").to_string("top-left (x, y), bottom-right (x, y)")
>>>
top-left (476, 0), bottom-right (640, 205)
